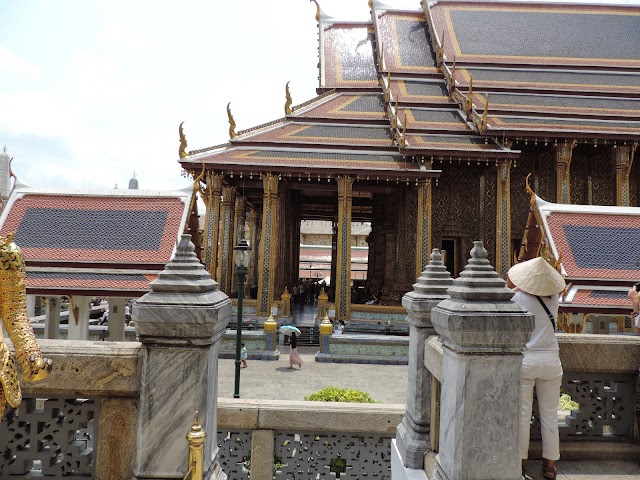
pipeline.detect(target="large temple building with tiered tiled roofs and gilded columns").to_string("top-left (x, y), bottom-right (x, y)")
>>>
top-left (179, 1), bottom-right (640, 320)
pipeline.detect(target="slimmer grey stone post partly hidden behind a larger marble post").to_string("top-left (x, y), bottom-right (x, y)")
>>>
top-left (396, 249), bottom-right (453, 470)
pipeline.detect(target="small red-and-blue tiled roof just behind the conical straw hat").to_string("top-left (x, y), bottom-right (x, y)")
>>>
top-left (518, 185), bottom-right (640, 313)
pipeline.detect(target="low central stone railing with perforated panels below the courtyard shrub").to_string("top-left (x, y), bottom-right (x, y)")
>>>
top-left (218, 398), bottom-right (405, 480)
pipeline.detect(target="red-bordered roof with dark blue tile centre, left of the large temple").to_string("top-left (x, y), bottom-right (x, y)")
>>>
top-left (0, 186), bottom-right (191, 296)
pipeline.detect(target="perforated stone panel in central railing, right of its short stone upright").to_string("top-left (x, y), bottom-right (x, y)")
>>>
top-left (275, 432), bottom-right (391, 480)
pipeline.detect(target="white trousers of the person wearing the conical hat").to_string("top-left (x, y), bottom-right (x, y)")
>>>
top-left (520, 351), bottom-right (562, 460)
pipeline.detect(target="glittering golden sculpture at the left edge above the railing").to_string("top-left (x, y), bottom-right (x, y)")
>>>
top-left (0, 234), bottom-right (53, 410)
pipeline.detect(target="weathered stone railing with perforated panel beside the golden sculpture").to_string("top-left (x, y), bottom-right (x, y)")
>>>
top-left (5, 340), bottom-right (141, 479)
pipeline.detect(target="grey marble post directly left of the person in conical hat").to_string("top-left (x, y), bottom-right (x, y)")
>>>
top-left (431, 241), bottom-right (534, 480)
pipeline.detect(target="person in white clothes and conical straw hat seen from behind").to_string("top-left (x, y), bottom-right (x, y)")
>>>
top-left (507, 257), bottom-right (565, 480)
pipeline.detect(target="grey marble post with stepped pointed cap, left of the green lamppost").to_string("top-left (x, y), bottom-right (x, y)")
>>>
top-left (133, 235), bottom-right (231, 480)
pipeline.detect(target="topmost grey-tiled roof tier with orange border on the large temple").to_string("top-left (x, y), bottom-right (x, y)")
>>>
top-left (431, 2), bottom-right (640, 68)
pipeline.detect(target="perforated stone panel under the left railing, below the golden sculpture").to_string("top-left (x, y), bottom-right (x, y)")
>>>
top-left (0, 398), bottom-right (99, 480)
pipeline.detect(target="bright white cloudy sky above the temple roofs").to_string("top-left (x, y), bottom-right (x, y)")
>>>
top-left (0, 0), bottom-right (640, 190)
